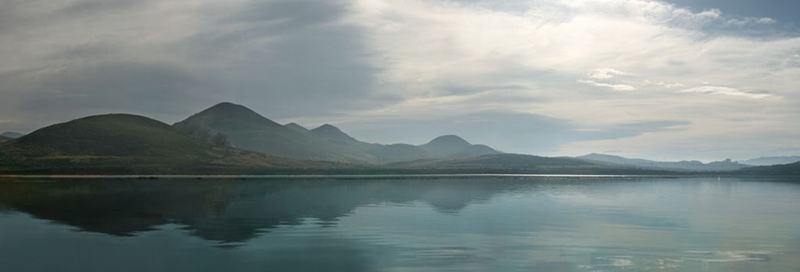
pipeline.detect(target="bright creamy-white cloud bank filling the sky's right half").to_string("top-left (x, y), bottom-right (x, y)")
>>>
top-left (341, 0), bottom-right (800, 157)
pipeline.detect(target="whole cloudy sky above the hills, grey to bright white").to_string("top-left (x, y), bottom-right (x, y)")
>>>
top-left (0, 0), bottom-right (800, 161)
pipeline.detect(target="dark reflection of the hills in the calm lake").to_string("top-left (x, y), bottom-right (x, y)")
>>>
top-left (0, 179), bottom-right (513, 242)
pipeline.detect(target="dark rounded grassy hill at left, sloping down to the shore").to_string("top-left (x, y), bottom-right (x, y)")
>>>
top-left (0, 114), bottom-right (343, 174)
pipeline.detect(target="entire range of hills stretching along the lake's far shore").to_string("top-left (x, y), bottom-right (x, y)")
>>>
top-left (0, 103), bottom-right (800, 175)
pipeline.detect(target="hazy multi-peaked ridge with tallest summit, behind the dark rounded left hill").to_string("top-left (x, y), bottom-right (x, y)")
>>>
top-left (174, 102), bottom-right (499, 164)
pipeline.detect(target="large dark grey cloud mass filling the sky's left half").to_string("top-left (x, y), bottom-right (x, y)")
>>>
top-left (0, 0), bottom-right (397, 129)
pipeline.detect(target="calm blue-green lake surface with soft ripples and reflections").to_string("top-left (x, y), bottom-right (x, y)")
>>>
top-left (0, 177), bottom-right (800, 272)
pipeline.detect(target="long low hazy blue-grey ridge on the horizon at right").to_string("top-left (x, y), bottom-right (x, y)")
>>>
top-left (576, 153), bottom-right (748, 172)
